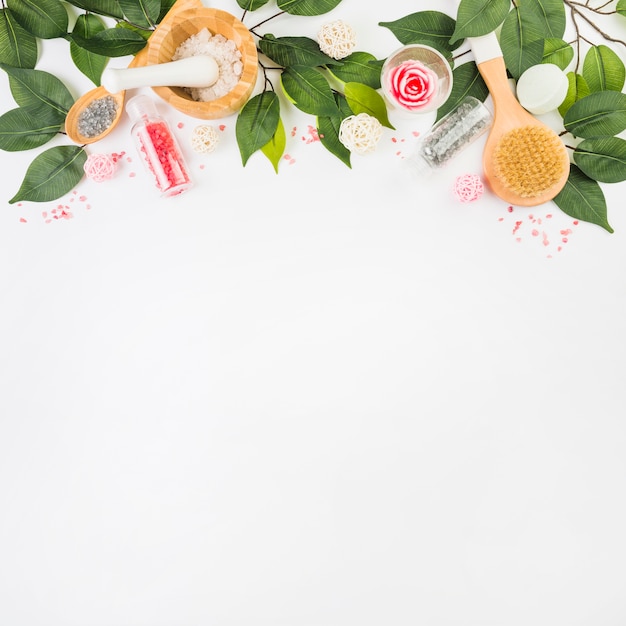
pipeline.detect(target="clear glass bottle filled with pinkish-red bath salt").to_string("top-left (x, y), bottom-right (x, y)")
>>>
top-left (126, 95), bottom-right (192, 198)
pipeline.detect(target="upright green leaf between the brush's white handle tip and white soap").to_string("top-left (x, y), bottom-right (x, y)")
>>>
top-left (500, 6), bottom-right (544, 79)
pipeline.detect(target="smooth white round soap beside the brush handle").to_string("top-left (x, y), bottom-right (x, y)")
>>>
top-left (517, 63), bottom-right (569, 115)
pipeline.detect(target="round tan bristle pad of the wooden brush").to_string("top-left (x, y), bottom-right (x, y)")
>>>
top-left (493, 126), bottom-right (569, 198)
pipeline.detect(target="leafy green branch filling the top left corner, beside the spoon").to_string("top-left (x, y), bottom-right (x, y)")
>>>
top-left (0, 0), bottom-right (175, 203)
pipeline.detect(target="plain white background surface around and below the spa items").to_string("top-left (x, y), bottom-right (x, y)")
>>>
top-left (0, 0), bottom-right (626, 626)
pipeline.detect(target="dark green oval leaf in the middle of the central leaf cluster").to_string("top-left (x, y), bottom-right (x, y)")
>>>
top-left (280, 65), bottom-right (337, 116)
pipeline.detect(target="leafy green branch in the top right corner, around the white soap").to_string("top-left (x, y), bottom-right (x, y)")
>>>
top-left (452, 0), bottom-right (626, 232)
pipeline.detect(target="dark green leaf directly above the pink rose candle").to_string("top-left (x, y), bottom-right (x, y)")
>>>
top-left (378, 11), bottom-right (463, 52)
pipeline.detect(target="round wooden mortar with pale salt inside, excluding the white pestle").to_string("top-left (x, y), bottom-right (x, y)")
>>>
top-left (148, 8), bottom-right (258, 120)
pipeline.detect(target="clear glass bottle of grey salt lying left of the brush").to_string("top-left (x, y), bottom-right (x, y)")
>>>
top-left (408, 96), bottom-right (492, 174)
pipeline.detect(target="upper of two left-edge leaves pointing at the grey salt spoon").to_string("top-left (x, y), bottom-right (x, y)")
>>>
top-left (0, 64), bottom-right (74, 117)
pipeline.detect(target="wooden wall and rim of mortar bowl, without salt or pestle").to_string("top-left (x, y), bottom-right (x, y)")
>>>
top-left (147, 8), bottom-right (258, 120)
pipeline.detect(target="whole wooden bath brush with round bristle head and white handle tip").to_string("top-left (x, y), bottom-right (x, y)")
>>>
top-left (469, 33), bottom-right (570, 206)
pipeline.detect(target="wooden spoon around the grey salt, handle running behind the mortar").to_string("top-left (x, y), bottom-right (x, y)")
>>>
top-left (65, 0), bottom-right (204, 145)
